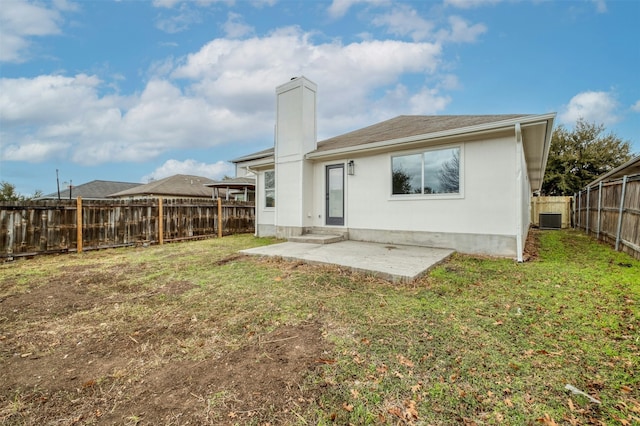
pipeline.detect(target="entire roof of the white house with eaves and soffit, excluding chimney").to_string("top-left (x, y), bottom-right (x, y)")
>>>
top-left (232, 113), bottom-right (555, 190)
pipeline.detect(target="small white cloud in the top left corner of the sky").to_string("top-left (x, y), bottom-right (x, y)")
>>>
top-left (0, 0), bottom-right (65, 63)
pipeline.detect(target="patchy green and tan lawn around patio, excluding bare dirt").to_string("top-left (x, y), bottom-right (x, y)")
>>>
top-left (0, 231), bottom-right (640, 425)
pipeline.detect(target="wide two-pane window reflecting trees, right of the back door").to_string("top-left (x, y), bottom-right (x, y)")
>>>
top-left (391, 147), bottom-right (460, 195)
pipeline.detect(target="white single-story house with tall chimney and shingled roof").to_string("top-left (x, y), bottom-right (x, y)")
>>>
top-left (233, 77), bottom-right (556, 261)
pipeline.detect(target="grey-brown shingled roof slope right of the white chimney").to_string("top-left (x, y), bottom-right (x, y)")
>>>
top-left (315, 114), bottom-right (526, 152)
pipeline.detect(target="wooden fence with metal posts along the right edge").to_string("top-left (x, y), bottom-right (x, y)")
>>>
top-left (574, 175), bottom-right (640, 259)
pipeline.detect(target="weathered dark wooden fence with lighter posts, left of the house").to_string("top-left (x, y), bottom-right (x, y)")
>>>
top-left (0, 197), bottom-right (255, 258)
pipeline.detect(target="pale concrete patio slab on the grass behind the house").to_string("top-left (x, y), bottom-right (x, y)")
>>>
top-left (241, 240), bottom-right (454, 282)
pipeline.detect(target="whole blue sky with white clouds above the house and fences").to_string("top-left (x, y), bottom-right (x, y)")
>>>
top-left (0, 0), bottom-right (640, 194)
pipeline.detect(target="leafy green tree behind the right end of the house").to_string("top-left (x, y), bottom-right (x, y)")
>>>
top-left (542, 118), bottom-right (631, 195)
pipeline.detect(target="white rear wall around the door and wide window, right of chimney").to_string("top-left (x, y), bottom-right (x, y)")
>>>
top-left (312, 137), bottom-right (528, 256)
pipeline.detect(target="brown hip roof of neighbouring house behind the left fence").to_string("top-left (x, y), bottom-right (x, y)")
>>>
top-left (109, 175), bottom-right (214, 198)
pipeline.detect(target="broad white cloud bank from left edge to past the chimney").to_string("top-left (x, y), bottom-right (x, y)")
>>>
top-left (0, 27), bottom-right (455, 165)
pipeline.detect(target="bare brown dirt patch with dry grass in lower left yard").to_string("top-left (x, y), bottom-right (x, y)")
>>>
top-left (0, 267), bottom-right (326, 425)
